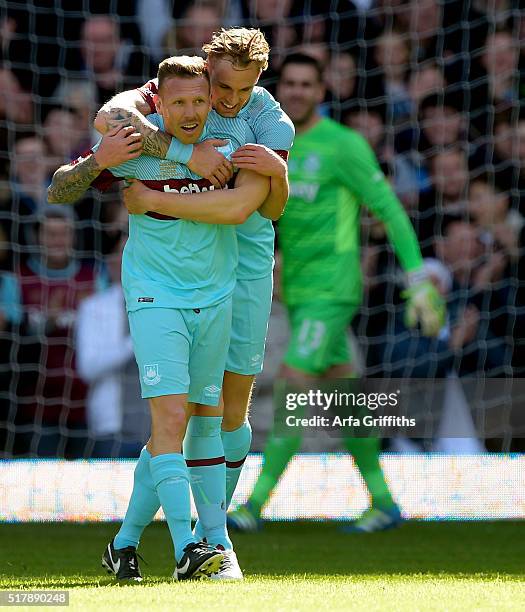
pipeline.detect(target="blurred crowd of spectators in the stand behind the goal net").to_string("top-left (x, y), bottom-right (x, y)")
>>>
top-left (0, 0), bottom-right (525, 457)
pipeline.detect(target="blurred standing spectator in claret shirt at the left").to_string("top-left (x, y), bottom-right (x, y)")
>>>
top-left (14, 207), bottom-right (97, 457)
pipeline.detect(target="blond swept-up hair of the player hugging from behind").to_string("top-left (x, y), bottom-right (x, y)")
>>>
top-left (202, 28), bottom-right (270, 70)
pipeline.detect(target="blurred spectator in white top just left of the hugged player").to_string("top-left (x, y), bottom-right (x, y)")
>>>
top-left (76, 234), bottom-right (150, 457)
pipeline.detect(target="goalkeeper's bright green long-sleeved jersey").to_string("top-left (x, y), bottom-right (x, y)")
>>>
top-left (279, 119), bottom-right (422, 305)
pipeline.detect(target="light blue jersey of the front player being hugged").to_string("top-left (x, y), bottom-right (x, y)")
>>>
top-left (96, 111), bottom-right (254, 311)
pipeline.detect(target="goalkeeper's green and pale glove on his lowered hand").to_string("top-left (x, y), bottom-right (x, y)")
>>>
top-left (401, 280), bottom-right (446, 336)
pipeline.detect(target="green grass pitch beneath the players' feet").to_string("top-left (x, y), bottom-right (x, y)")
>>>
top-left (0, 522), bottom-right (525, 612)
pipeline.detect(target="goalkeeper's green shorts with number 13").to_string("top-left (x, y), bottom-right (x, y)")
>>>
top-left (284, 302), bottom-right (357, 376)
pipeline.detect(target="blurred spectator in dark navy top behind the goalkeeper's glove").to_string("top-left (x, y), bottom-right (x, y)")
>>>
top-left (380, 220), bottom-right (511, 378)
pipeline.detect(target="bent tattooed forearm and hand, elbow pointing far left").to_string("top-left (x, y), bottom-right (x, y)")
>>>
top-left (47, 126), bottom-right (142, 204)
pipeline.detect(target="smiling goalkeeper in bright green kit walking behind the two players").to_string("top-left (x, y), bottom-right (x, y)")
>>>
top-left (228, 54), bottom-right (445, 532)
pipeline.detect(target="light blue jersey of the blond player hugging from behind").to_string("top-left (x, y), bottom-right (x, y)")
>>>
top-left (137, 79), bottom-right (295, 280)
